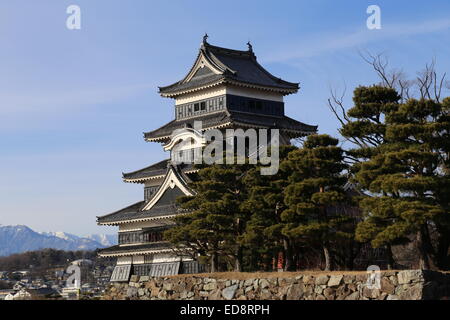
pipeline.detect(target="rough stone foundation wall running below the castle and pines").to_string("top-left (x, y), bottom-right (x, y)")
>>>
top-left (103, 270), bottom-right (450, 300)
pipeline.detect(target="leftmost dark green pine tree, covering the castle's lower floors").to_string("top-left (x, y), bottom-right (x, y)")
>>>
top-left (164, 164), bottom-right (248, 272)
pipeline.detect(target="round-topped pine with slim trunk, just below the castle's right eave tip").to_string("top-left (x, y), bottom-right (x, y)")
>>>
top-left (280, 135), bottom-right (352, 270)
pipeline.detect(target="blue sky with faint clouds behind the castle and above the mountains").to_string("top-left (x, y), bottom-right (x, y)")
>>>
top-left (0, 0), bottom-right (450, 235)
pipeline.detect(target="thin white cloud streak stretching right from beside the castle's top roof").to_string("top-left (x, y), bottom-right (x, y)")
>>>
top-left (262, 19), bottom-right (450, 62)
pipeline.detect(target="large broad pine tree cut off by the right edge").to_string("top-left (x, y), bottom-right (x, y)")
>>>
top-left (355, 99), bottom-right (450, 269)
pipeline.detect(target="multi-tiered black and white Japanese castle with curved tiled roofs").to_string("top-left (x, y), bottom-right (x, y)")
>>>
top-left (97, 35), bottom-right (317, 281)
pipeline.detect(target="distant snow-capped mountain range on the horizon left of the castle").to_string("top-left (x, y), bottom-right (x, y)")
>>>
top-left (0, 226), bottom-right (117, 256)
